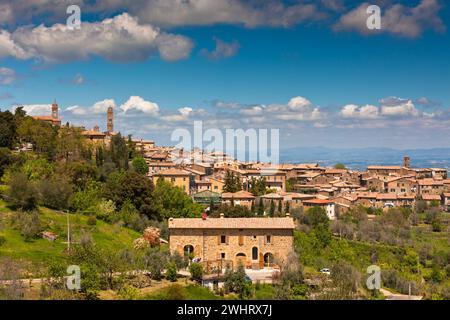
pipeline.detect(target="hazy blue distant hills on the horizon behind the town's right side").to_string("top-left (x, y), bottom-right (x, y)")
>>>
top-left (280, 147), bottom-right (450, 170)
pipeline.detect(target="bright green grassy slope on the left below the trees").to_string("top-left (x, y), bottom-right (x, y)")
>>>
top-left (0, 200), bottom-right (140, 264)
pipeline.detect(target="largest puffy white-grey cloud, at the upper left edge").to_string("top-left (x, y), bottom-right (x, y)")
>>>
top-left (0, 13), bottom-right (193, 62)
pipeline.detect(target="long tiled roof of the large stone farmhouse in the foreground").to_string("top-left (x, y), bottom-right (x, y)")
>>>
top-left (169, 217), bottom-right (295, 229)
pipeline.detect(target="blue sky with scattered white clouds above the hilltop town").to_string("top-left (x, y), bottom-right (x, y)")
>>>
top-left (0, 0), bottom-right (450, 149)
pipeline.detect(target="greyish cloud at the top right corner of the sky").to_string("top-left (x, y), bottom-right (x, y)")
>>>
top-left (333, 0), bottom-right (445, 38)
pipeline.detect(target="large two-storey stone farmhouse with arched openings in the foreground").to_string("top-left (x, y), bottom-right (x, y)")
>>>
top-left (169, 215), bottom-right (295, 273)
